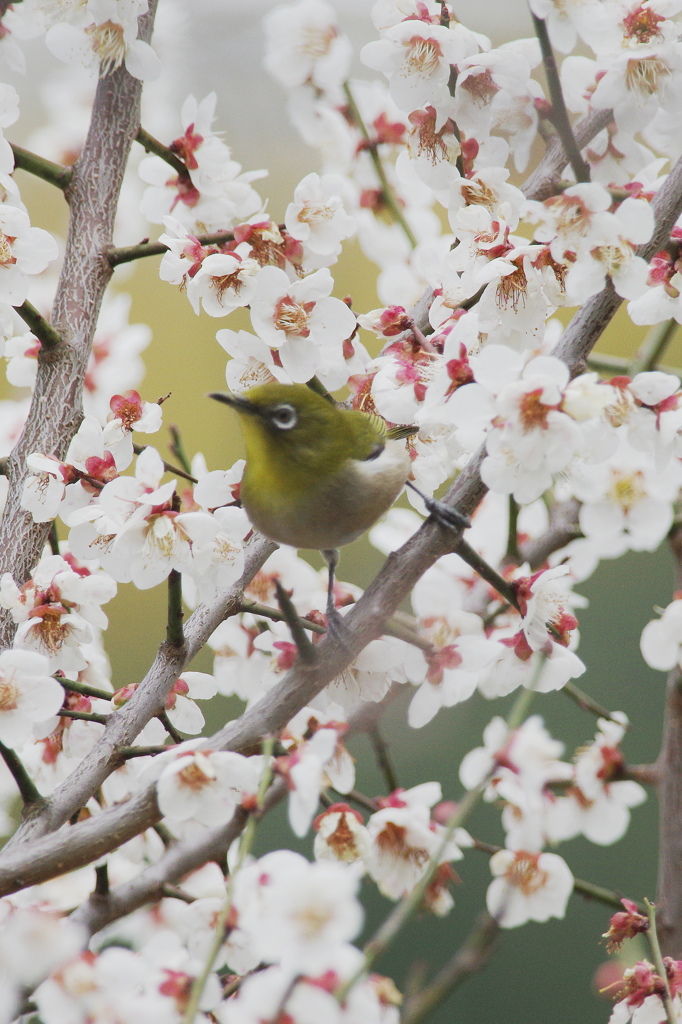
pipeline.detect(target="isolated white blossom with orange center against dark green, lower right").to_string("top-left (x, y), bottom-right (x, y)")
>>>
top-left (485, 850), bottom-right (573, 928)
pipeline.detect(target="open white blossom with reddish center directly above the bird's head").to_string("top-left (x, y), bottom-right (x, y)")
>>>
top-left (251, 266), bottom-right (355, 389)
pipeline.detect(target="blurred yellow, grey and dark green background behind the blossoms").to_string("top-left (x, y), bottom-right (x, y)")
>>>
top-left (5, 0), bottom-right (682, 1024)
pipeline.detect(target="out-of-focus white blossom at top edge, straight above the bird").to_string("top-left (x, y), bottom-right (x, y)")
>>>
top-left (263, 0), bottom-right (352, 92)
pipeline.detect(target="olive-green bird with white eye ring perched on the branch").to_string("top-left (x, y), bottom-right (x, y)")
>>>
top-left (209, 382), bottom-right (470, 636)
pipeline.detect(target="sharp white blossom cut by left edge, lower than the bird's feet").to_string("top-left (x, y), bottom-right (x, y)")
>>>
top-left (0, 649), bottom-right (65, 746)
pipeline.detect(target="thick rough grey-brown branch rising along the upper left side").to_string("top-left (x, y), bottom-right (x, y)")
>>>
top-left (0, 3), bottom-right (156, 647)
